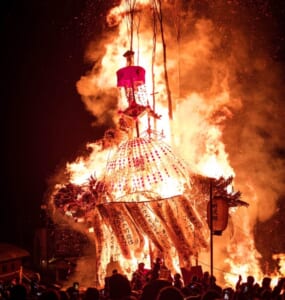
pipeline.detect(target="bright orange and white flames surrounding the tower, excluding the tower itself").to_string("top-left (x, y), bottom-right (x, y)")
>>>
top-left (47, 1), bottom-right (284, 286)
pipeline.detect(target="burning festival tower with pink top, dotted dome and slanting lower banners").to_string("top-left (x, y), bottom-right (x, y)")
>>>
top-left (45, 0), bottom-right (260, 283)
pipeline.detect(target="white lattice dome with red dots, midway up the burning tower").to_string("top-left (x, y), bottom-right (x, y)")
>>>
top-left (105, 138), bottom-right (190, 202)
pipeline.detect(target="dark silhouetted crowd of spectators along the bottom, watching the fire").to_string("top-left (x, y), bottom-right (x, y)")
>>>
top-left (0, 258), bottom-right (285, 300)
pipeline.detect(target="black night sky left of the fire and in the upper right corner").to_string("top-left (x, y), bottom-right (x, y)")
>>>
top-left (0, 0), bottom-right (285, 260)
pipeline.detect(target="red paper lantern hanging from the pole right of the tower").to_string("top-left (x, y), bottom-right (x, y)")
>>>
top-left (207, 197), bottom-right (229, 235)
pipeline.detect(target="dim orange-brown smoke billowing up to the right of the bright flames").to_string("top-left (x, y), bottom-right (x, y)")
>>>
top-left (173, 1), bottom-right (285, 272)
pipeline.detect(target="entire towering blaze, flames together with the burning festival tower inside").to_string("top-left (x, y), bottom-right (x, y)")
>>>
top-left (45, 0), bottom-right (284, 285)
